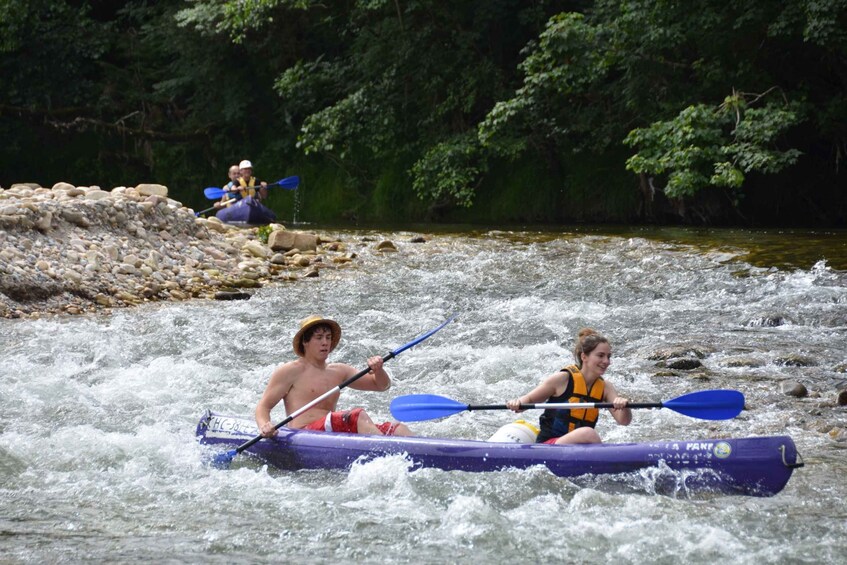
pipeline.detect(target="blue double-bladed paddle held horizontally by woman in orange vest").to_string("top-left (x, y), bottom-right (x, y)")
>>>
top-left (391, 390), bottom-right (744, 422)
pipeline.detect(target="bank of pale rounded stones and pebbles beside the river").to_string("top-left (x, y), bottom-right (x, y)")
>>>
top-left (0, 182), bottom-right (378, 318)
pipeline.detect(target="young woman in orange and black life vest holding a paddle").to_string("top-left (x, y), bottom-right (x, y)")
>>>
top-left (506, 328), bottom-right (632, 444)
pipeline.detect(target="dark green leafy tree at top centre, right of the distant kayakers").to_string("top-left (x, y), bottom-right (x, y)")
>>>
top-left (209, 0), bottom-right (550, 212)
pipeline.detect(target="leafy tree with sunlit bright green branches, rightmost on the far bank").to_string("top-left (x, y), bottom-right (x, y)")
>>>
top-left (479, 0), bottom-right (847, 220)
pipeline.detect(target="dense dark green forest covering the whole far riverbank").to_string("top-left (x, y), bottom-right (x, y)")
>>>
top-left (0, 0), bottom-right (847, 226)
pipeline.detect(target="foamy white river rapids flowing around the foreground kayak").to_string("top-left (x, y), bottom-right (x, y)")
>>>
top-left (0, 230), bottom-right (847, 564)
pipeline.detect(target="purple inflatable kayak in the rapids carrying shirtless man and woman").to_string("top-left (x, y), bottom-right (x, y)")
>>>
top-left (196, 412), bottom-right (803, 496)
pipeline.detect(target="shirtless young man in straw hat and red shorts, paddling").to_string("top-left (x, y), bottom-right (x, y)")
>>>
top-left (256, 316), bottom-right (412, 437)
